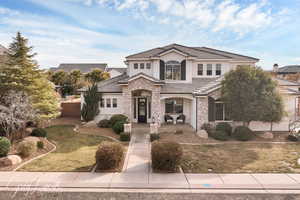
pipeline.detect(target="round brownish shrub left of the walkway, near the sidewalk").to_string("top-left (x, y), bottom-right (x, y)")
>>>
top-left (96, 142), bottom-right (124, 170)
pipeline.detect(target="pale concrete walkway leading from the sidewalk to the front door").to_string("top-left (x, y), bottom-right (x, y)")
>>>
top-left (123, 127), bottom-right (151, 173)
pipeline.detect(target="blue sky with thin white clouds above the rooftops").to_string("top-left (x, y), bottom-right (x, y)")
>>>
top-left (0, 0), bottom-right (300, 69)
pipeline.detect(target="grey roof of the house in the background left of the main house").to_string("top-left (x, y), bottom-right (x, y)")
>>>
top-left (50, 63), bottom-right (107, 73)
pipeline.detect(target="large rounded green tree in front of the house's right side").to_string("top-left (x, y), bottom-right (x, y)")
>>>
top-left (222, 66), bottom-right (283, 125)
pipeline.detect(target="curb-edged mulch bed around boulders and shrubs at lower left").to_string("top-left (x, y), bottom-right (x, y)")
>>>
top-left (0, 138), bottom-right (54, 171)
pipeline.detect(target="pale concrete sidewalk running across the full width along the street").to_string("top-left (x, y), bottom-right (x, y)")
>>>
top-left (0, 172), bottom-right (300, 190)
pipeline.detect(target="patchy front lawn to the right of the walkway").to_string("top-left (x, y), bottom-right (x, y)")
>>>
top-left (181, 143), bottom-right (300, 173)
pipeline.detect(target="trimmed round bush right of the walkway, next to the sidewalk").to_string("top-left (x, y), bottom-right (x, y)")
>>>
top-left (151, 141), bottom-right (183, 172)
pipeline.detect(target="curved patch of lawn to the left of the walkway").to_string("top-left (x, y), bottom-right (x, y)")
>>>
top-left (19, 125), bottom-right (108, 172)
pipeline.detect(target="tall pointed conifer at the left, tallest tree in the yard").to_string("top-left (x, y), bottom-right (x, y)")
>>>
top-left (0, 32), bottom-right (59, 119)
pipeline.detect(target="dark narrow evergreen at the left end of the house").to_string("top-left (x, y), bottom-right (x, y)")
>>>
top-left (81, 84), bottom-right (101, 122)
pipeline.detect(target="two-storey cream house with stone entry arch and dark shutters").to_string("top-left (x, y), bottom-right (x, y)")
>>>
top-left (81, 44), bottom-right (300, 130)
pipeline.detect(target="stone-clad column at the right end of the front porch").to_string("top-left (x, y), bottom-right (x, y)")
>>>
top-left (197, 97), bottom-right (208, 130)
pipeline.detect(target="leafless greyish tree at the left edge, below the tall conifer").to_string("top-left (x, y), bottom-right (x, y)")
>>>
top-left (0, 91), bottom-right (36, 140)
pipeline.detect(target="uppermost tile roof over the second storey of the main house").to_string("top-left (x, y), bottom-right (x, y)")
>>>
top-left (126, 44), bottom-right (259, 62)
